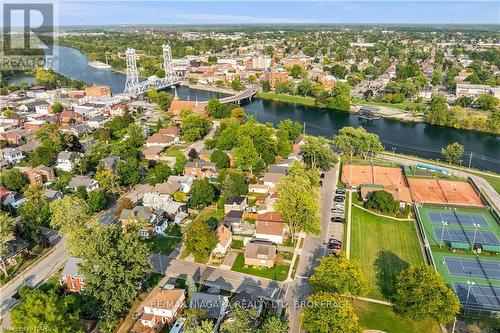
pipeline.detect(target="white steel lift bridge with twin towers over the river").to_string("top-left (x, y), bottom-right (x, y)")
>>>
top-left (124, 44), bottom-right (181, 95)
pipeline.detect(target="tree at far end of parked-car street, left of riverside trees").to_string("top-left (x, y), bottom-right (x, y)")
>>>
top-left (300, 136), bottom-right (337, 169)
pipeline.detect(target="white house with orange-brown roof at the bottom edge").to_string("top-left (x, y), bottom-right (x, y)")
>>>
top-left (132, 287), bottom-right (186, 332)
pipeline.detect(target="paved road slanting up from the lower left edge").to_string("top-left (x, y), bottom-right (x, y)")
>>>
top-left (0, 239), bottom-right (68, 322)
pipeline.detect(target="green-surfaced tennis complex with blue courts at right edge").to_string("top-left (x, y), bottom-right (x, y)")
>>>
top-left (418, 207), bottom-right (500, 311)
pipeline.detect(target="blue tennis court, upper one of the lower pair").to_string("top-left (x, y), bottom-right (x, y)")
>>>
top-left (444, 257), bottom-right (500, 280)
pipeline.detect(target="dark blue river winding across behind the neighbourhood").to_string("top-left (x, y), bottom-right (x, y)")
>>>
top-left (5, 46), bottom-right (500, 173)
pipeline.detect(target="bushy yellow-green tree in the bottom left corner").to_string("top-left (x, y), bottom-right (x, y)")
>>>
top-left (10, 287), bottom-right (83, 333)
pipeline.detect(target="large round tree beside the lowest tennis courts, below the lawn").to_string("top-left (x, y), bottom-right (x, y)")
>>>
top-left (394, 265), bottom-right (460, 324)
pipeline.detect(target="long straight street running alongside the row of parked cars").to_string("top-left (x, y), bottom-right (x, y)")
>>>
top-left (285, 165), bottom-right (338, 333)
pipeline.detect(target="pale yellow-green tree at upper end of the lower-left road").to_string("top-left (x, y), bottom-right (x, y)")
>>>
top-left (50, 195), bottom-right (89, 257)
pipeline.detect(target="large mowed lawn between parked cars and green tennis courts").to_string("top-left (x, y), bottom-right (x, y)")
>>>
top-left (350, 206), bottom-right (424, 300)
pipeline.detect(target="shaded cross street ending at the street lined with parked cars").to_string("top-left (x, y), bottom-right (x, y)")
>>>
top-left (151, 254), bottom-right (284, 301)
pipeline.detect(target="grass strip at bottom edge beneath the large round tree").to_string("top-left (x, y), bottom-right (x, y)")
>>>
top-left (354, 301), bottom-right (441, 333)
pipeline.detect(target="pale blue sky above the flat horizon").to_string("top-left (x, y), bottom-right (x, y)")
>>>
top-left (2, 0), bottom-right (500, 26)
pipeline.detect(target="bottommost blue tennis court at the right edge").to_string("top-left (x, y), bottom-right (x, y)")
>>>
top-left (453, 282), bottom-right (500, 310)
